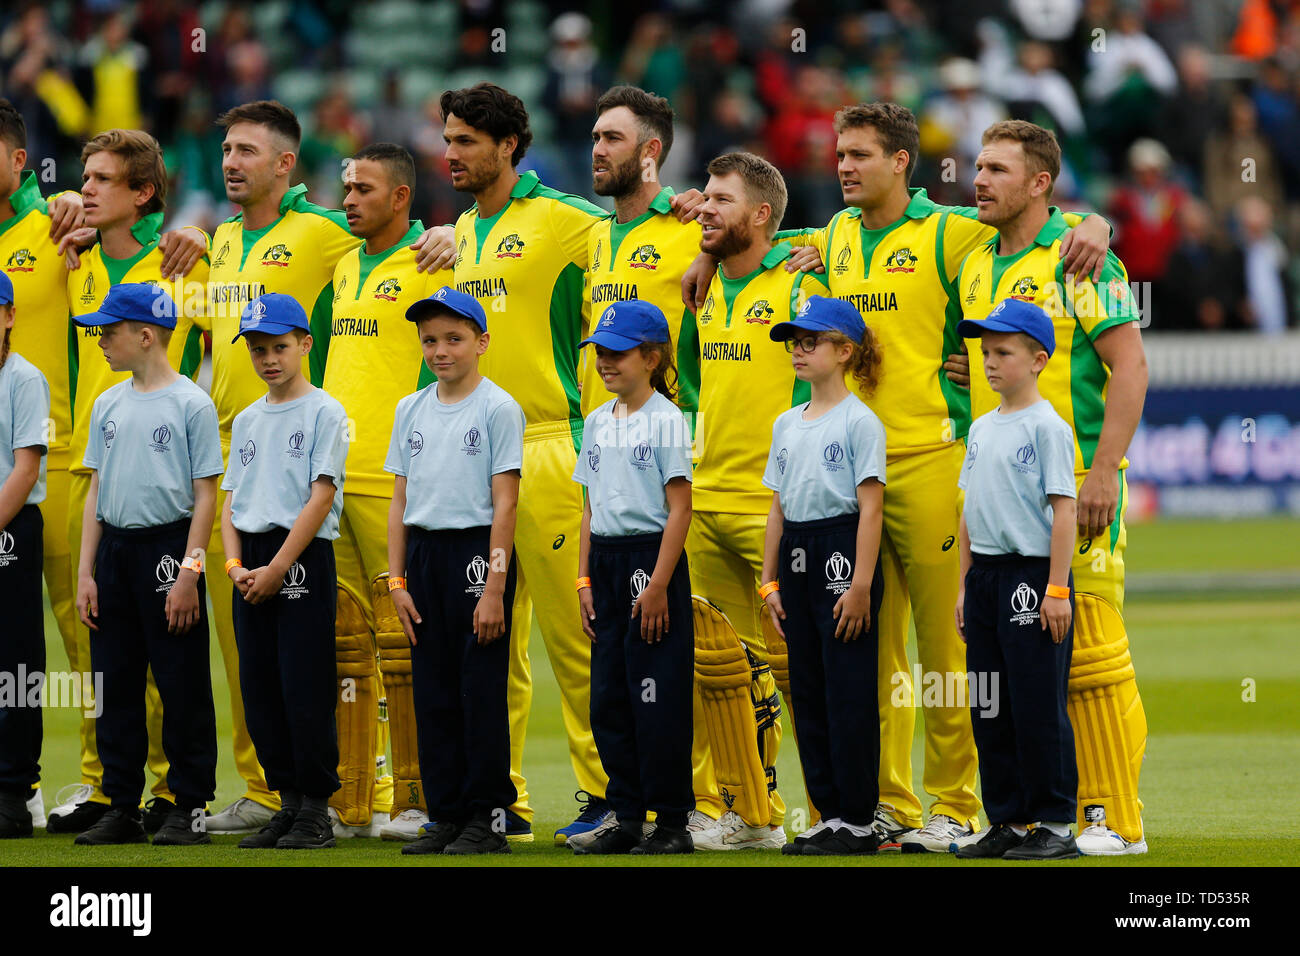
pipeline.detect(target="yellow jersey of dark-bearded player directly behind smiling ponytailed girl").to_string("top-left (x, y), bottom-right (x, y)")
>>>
top-left (581, 187), bottom-right (699, 418)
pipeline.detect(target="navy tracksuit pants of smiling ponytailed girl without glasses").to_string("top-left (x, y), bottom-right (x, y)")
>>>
top-left (588, 535), bottom-right (696, 829)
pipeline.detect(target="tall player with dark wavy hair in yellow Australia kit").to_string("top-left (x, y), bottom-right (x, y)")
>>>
top-left (441, 83), bottom-right (608, 844)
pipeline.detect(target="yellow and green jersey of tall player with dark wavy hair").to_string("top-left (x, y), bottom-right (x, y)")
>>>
top-left (455, 172), bottom-right (607, 449)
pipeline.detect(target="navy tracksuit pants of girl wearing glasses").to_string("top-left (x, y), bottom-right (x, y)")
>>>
top-left (764, 514), bottom-right (884, 826)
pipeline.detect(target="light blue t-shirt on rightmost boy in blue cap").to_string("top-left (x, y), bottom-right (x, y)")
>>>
top-left (957, 398), bottom-right (1075, 558)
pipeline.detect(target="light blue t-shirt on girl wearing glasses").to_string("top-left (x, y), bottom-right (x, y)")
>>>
top-left (763, 394), bottom-right (885, 522)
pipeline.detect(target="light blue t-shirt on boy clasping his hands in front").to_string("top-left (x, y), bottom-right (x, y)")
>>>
top-left (221, 389), bottom-right (347, 541)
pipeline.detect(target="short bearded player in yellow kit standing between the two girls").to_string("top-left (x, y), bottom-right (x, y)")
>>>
top-left (686, 152), bottom-right (826, 849)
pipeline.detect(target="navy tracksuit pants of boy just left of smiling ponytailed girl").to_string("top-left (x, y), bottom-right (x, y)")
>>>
top-left (406, 525), bottom-right (519, 823)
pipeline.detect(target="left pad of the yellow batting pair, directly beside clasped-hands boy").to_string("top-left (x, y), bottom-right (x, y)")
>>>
top-left (330, 588), bottom-right (378, 826)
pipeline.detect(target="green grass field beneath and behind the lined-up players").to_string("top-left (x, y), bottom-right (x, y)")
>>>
top-left (0, 520), bottom-right (1300, 868)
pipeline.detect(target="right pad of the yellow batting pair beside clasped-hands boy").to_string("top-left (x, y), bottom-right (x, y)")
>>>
top-left (371, 574), bottom-right (425, 816)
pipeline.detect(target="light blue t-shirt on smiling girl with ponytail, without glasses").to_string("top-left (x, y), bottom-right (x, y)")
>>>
top-left (573, 392), bottom-right (690, 536)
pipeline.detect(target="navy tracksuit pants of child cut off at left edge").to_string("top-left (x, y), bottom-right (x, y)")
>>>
top-left (0, 505), bottom-right (46, 800)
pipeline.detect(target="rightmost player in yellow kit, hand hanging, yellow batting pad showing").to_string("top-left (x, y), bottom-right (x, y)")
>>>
top-left (957, 120), bottom-right (1147, 856)
